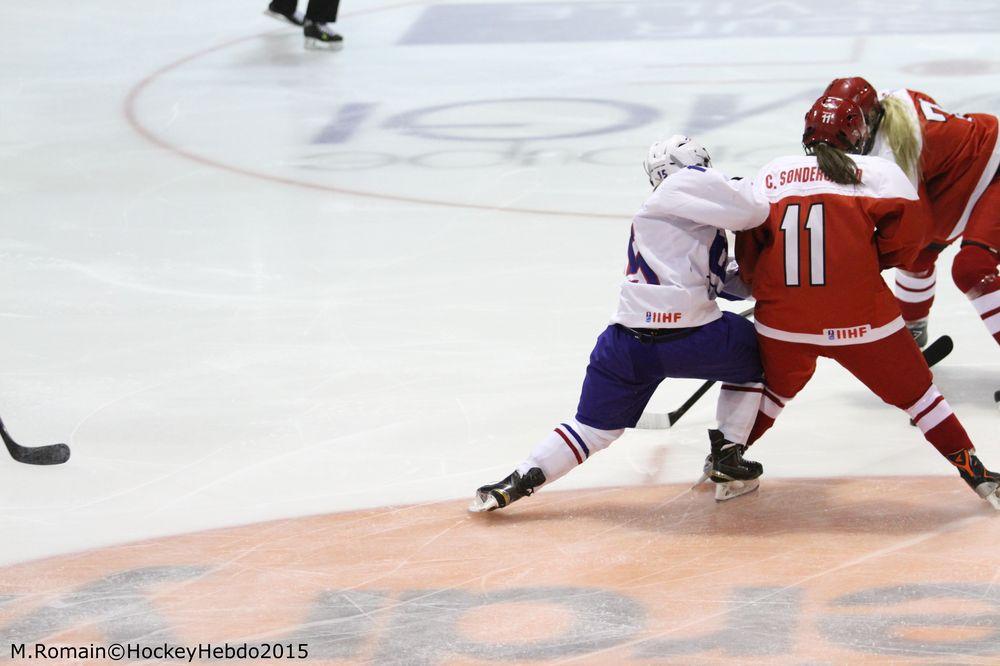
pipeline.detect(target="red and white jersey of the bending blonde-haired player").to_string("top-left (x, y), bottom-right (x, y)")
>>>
top-left (871, 90), bottom-right (1000, 244)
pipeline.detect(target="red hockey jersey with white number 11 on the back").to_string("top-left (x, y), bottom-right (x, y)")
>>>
top-left (737, 156), bottom-right (928, 345)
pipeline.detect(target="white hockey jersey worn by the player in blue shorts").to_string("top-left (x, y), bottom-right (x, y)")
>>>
top-left (611, 167), bottom-right (769, 328)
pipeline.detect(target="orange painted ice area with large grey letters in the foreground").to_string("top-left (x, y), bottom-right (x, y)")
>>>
top-left (0, 475), bottom-right (1000, 664)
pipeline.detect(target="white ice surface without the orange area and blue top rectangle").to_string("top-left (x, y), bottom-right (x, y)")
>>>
top-left (0, 0), bottom-right (1000, 563)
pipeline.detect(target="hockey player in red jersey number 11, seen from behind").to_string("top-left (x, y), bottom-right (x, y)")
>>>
top-left (737, 96), bottom-right (1000, 510)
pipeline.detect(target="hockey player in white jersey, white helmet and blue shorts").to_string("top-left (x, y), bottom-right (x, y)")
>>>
top-left (469, 135), bottom-right (768, 512)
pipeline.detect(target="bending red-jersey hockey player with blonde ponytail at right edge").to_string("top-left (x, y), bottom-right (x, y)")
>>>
top-left (824, 77), bottom-right (1000, 346)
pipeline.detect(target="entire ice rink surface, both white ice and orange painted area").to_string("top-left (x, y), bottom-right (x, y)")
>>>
top-left (0, 0), bottom-right (1000, 664)
